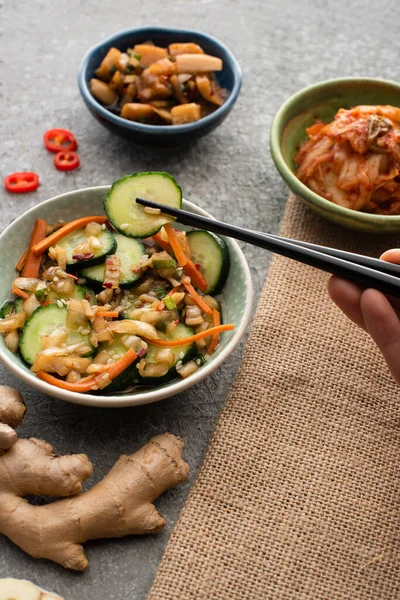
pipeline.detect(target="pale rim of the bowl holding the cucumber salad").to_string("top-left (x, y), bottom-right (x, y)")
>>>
top-left (0, 185), bottom-right (254, 408)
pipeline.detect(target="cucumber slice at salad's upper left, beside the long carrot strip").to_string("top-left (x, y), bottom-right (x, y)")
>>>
top-left (58, 229), bottom-right (116, 271)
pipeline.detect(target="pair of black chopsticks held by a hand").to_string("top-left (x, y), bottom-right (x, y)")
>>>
top-left (136, 198), bottom-right (400, 297)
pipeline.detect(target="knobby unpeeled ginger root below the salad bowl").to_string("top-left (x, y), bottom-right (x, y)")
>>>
top-left (0, 387), bottom-right (189, 571)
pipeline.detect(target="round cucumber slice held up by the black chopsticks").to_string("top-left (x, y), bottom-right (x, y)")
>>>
top-left (104, 171), bottom-right (182, 238)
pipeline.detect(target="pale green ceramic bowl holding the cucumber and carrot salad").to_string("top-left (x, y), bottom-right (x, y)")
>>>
top-left (0, 186), bottom-right (253, 407)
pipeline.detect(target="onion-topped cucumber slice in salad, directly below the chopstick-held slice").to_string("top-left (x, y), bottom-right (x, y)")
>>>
top-left (80, 233), bottom-right (146, 290)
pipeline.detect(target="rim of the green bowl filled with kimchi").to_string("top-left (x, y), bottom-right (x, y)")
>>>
top-left (270, 77), bottom-right (400, 225)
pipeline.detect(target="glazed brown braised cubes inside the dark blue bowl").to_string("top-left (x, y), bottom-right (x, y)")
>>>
top-left (90, 41), bottom-right (226, 125)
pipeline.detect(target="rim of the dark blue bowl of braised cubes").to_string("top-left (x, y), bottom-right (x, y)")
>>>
top-left (78, 25), bottom-right (242, 136)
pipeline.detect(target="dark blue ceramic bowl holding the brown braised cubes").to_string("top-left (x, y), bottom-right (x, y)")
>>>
top-left (78, 27), bottom-right (242, 146)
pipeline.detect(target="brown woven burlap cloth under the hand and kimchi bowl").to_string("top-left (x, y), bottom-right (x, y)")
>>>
top-left (148, 198), bottom-right (400, 600)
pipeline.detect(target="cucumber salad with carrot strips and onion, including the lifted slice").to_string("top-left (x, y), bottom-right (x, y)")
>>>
top-left (0, 172), bottom-right (233, 394)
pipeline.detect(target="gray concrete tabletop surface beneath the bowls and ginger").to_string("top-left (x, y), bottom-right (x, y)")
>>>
top-left (0, 0), bottom-right (400, 600)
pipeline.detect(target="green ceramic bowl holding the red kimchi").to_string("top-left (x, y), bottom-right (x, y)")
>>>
top-left (270, 77), bottom-right (400, 233)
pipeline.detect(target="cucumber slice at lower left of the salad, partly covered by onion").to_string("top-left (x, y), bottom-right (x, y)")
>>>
top-left (19, 304), bottom-right (91, 365)
